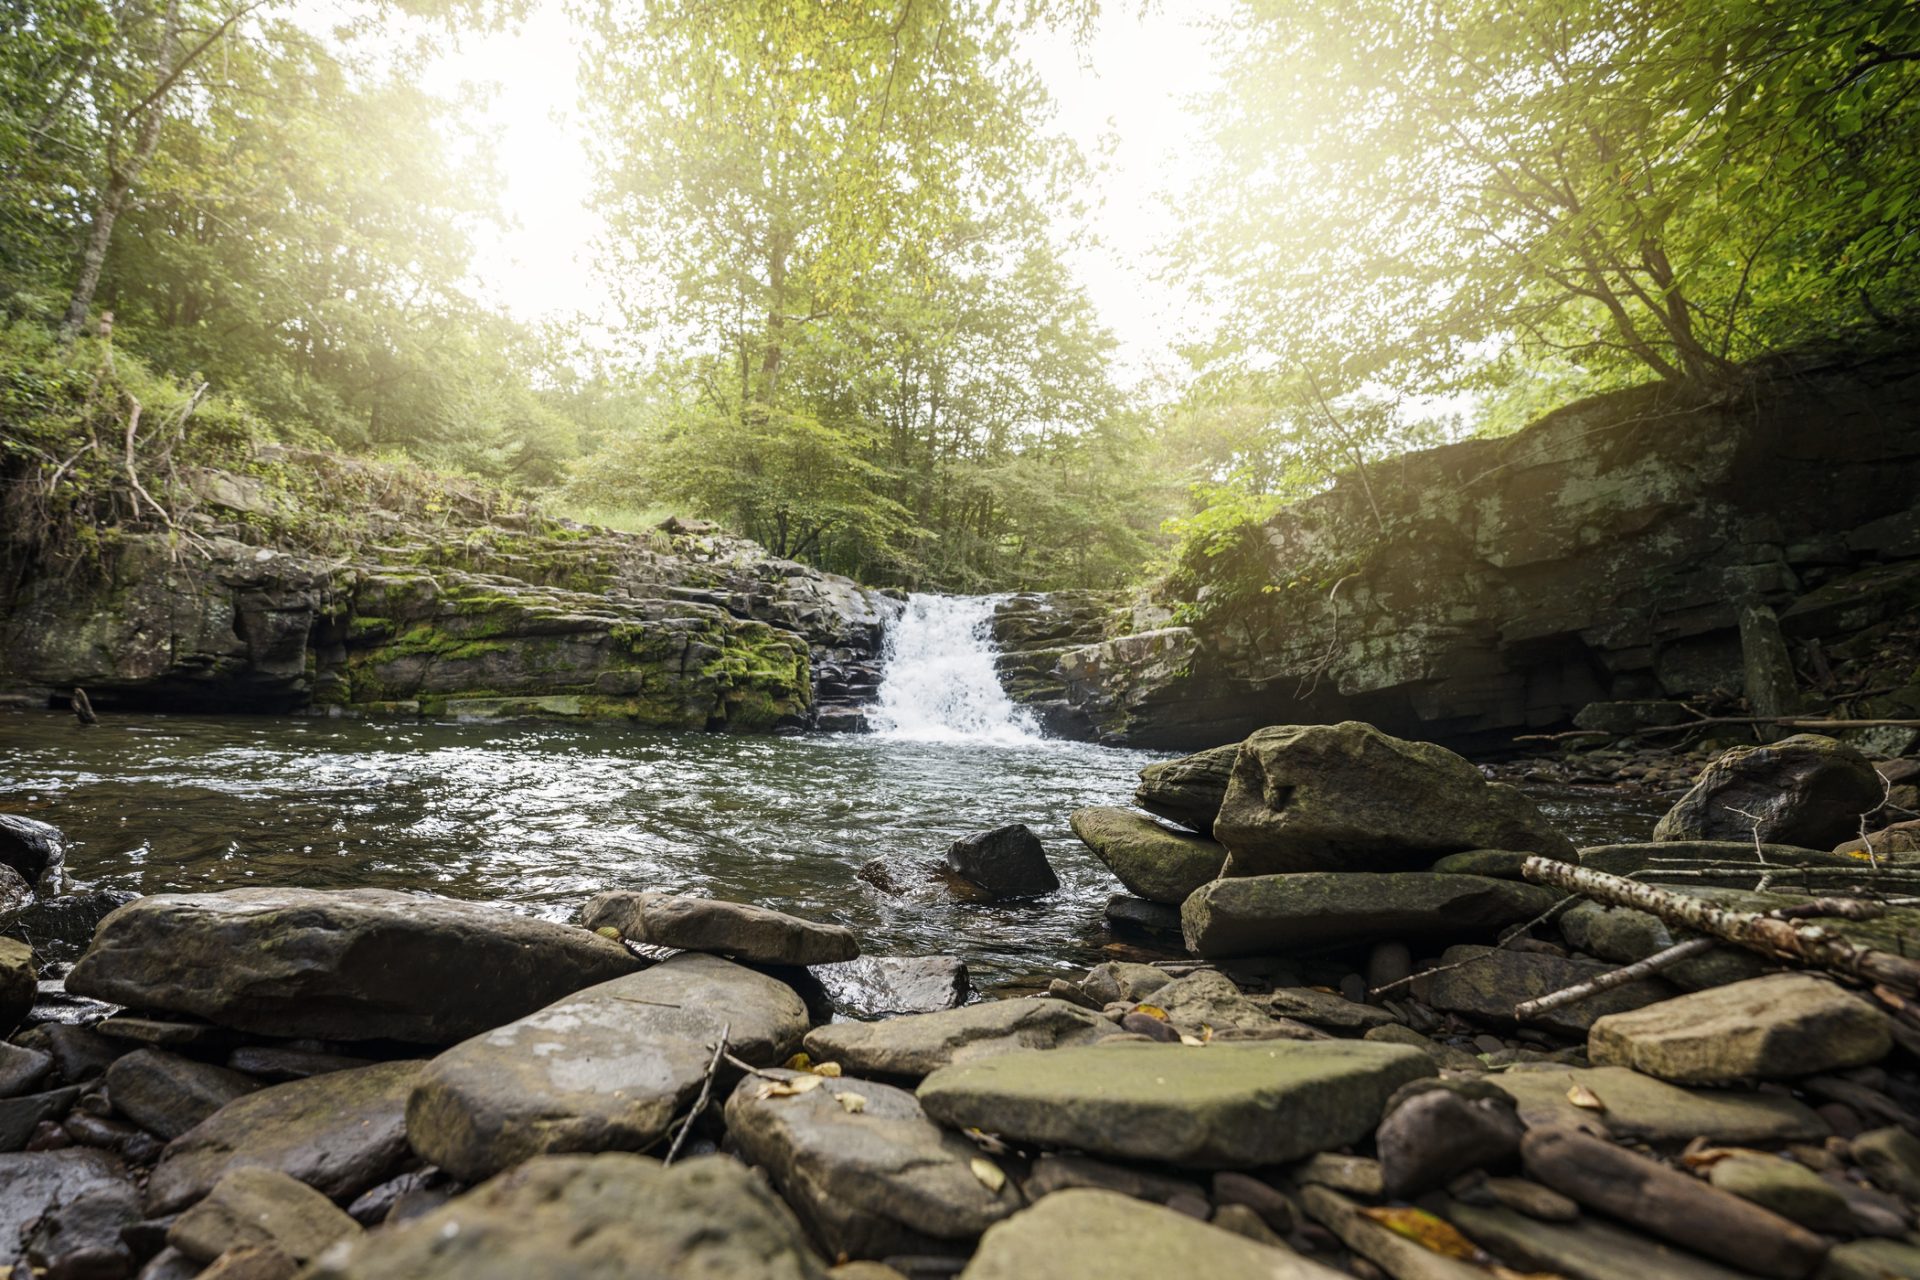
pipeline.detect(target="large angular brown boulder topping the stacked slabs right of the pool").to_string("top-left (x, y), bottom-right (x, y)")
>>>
top-left (1213, 720), bottom-right (1574, 875)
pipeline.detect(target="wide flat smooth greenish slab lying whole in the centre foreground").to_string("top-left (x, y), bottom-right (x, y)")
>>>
top-left (920, 1040), bottom-right (1434, 1169)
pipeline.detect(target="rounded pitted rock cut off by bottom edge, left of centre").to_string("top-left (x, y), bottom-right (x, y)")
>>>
top-left (305, 1153), bottom-right (826, 1280)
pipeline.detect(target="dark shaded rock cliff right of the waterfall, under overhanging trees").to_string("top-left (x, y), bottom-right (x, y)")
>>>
top-left (1029, 349), bottom-right (1920, 747)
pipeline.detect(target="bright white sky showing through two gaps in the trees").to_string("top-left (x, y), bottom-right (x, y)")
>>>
top-left (405, 0), bottom-right (1227, 382)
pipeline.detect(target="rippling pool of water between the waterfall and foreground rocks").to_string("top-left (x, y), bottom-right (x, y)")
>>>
top-left (0, 712), bottom-right (1663, 986)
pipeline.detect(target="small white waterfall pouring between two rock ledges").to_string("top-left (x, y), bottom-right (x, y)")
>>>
top-left (868, 595), bottom-right (1041, 747)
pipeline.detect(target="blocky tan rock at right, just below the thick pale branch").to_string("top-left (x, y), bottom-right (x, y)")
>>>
top-left (1588, 973), bottom-right (1893, 1084)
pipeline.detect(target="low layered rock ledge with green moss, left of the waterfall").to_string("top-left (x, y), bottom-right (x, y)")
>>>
top-left (0, 468), bottom-right (897, 729)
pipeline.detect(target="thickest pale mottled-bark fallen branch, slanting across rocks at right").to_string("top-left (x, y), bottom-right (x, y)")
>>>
top-left (1521, 858), bottom-right (1920, 992)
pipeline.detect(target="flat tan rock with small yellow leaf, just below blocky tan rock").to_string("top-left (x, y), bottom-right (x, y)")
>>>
top-left (1488, 1067), bottom-right (1830, 1146)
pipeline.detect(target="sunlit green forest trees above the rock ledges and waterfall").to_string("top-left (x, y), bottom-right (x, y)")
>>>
top-left (0, 0), bottom-right (1920, 591)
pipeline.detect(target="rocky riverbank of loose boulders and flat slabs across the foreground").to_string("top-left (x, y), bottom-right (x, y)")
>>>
top-left (0, 723), bottom-right (1920, 1280)
